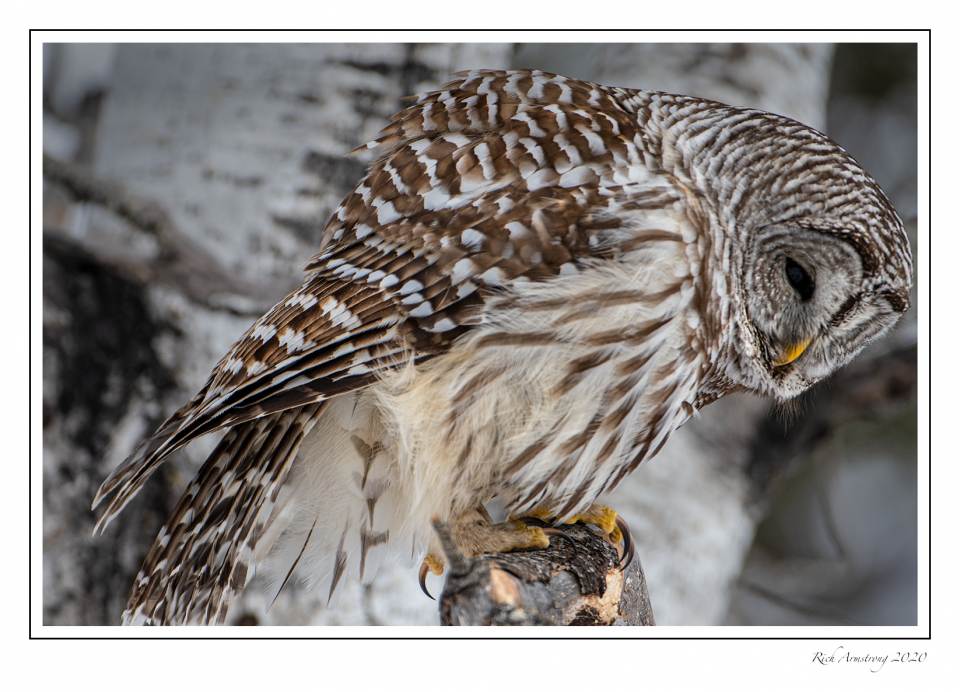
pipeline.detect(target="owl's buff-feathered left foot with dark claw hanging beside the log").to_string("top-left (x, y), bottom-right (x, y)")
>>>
top-left (420, 507), bottom-right (550, 598)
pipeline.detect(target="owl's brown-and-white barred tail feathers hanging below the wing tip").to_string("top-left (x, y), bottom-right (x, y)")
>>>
top-left (123, 404), bottom-right (322, 624)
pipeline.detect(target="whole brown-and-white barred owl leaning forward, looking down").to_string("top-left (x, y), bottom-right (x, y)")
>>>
top-left (94, 70), bottom-right (912, 623)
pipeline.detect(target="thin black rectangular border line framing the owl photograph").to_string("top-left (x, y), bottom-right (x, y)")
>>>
top-left (27, 28), bottom-right (933, 641)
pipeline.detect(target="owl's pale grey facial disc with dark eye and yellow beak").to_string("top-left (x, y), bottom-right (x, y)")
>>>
top-left (741, 211), bottom-right (910, 399)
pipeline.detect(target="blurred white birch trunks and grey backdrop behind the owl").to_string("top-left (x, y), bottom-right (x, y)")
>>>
top-left (43, 43), bottom-right (918, 625)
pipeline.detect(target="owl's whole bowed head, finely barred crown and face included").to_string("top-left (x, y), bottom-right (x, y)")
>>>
top-left (688, 111), bottom-right (913, 400)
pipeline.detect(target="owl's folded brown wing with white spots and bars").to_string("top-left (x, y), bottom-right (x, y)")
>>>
top-left (88, 71), bottom-right (681, 530)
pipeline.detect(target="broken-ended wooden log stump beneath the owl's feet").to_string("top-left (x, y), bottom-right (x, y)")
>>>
top-left (434, 521), bottom-right (654, 625)
